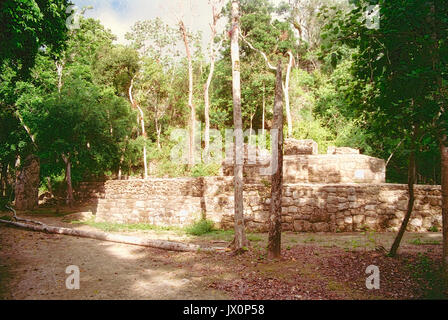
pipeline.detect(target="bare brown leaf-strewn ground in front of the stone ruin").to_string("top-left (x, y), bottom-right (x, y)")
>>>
top-left (0, 210), bottom-right (445, 299)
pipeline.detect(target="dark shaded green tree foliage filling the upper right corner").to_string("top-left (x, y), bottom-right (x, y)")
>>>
top-left (321, 1), bottom-right (448, 182)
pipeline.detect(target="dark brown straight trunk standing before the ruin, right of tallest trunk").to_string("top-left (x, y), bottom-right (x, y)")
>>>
top-left (268, 62), bottom-right (283, 259)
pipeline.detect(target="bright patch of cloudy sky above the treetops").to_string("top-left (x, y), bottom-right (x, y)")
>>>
top-left (72, 0), bottom-right (280, 47)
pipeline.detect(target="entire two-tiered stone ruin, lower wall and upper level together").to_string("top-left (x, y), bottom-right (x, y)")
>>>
top-left (61, 140), bottom-right (442, 232)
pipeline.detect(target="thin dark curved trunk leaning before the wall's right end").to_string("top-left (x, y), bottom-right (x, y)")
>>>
top-left (389, 135), bottom-right (417, 257)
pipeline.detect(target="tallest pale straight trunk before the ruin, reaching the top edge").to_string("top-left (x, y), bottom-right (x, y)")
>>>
top-left (230, 0), bottom-right (249, 253)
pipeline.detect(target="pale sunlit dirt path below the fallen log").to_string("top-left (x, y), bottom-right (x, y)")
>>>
top-left (0, 214), bottom-right (227, 299)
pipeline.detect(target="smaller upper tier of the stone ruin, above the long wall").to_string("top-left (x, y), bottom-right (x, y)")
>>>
top-left (223, 139), bottom-right (386, 183)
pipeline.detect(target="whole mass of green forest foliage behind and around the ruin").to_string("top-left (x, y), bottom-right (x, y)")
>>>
top-left (0, 0), bottom-right (448, 197)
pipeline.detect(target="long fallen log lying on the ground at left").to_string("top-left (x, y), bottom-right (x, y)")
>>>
top-left (0, 219), bottom-right (225, 252)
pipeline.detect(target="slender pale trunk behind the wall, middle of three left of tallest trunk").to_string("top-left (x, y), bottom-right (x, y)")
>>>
top-left (179, 20), bottom-right (196, 169)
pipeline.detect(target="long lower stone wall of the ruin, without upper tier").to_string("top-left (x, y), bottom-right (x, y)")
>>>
top-left (79, 176), bottom-right (441, 232)
